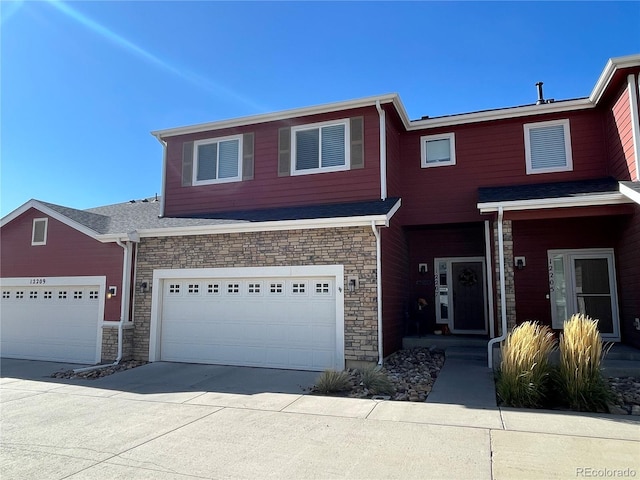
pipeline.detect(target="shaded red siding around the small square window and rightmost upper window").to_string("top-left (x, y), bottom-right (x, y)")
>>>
top-left (398, 111), bottom-right (607, 225)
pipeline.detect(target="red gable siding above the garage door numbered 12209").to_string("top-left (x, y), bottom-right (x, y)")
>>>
top-left (0, 208), bottom-right (123, 320)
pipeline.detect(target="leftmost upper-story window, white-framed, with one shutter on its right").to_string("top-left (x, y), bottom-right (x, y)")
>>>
top-left (193, 135), bottom-right (242, 185)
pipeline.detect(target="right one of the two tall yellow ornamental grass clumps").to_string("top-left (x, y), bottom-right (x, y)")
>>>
top-left (558, 315), bottom-right (612, 412)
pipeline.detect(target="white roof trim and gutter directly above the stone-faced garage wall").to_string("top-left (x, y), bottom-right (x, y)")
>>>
top-left (100, 200), bottom-right (401, 242)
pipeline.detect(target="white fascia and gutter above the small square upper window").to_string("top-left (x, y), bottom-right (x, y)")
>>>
top-left (407, 98), bottom-right (595, 130)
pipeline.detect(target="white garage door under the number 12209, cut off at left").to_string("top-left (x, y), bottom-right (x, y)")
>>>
top-left (0, 279), bottom-right (104, 363)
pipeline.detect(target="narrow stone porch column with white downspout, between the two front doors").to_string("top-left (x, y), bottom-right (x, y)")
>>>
top-left (493, 220), bottom-right (516, 335)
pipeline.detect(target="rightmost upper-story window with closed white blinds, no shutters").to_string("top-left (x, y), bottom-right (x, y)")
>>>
top-left (524, 120), bottom-right (573, 175)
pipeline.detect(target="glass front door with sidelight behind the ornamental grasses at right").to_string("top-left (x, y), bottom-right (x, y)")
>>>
top-left (548, 249), bottom-right (620, 341)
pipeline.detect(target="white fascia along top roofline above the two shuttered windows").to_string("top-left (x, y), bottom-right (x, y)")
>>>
top-left (151, 93), bottom-right (404, 139)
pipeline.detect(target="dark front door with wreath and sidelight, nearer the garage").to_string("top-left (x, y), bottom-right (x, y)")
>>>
top-left (435, 257), bottom-right (487, 334)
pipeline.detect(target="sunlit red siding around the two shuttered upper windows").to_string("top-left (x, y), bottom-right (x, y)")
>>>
top-left (165, 107), bottom-right (380, 216)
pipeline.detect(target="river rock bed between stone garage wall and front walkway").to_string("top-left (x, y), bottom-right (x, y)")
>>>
top-left (324, 348), bottom-right (444, 402)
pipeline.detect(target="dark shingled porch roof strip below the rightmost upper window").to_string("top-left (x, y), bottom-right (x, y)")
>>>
top-left (478, 177), bottom-right (619, 203)
